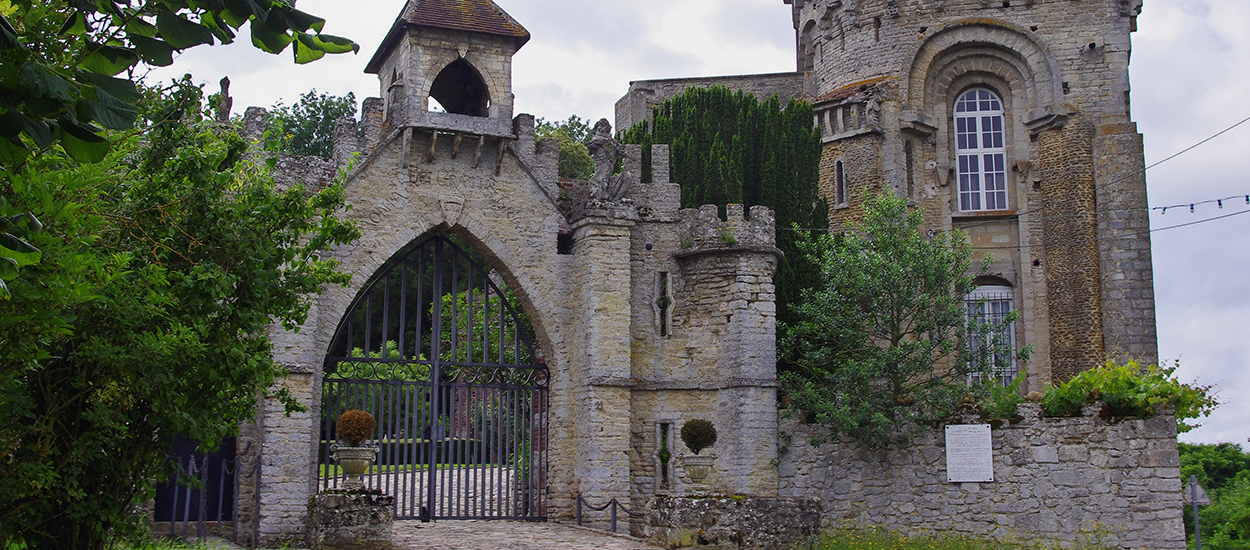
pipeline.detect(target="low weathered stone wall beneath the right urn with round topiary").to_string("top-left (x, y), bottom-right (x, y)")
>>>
top-left (643, 495), bottom-right (820, 550)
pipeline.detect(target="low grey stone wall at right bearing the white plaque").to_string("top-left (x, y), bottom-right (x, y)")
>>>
top-left (779, 403), bottom-right (1185, 549)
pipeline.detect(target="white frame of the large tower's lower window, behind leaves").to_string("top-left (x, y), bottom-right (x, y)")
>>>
top-left (964, 285), bottom-right (1019, 386)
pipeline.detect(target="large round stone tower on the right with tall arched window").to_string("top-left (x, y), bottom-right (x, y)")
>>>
top-left (785, 0), bottom-right (1158, 389)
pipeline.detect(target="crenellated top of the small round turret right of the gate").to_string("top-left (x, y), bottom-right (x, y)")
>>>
top-left (678, 204), bottom-right (780, 255)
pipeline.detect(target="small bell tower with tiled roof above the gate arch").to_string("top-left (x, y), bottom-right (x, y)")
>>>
top-left (365, 0), bottom-right (530, 138)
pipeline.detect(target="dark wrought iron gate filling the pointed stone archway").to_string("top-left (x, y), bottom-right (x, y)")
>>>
top-left (318, 234), bottom-right (548, 519)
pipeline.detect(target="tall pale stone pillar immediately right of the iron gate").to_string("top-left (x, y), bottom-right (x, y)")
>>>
top-left (571, 204), bottom-right (638, 503)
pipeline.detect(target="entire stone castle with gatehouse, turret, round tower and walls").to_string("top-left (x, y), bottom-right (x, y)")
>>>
top-left (202, 0), bottom-right (1184, 548)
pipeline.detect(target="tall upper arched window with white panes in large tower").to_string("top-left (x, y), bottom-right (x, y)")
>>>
top-left (955, 88), bottom-right (1008, 213)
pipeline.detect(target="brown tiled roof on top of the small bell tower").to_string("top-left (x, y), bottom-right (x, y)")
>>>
top-left (365, 0), bottom-right (530, 74)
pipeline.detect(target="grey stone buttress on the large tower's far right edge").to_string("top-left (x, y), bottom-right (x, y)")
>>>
top-left (1094, 115), bottom-right (1159, 364)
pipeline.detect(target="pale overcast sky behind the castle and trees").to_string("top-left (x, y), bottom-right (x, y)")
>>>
top-left (154, 0), bottom-right (1250, 443)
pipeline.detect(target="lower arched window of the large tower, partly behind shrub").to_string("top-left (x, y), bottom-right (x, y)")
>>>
top-left (964, 285), bottom-right (1016, 385)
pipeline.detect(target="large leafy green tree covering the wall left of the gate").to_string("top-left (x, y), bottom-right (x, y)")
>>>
top-left (0, 80), bottom-right (358, 549)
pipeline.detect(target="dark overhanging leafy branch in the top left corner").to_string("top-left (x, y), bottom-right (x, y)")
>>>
top-left (0, 0), bottom-right (360, 168)
